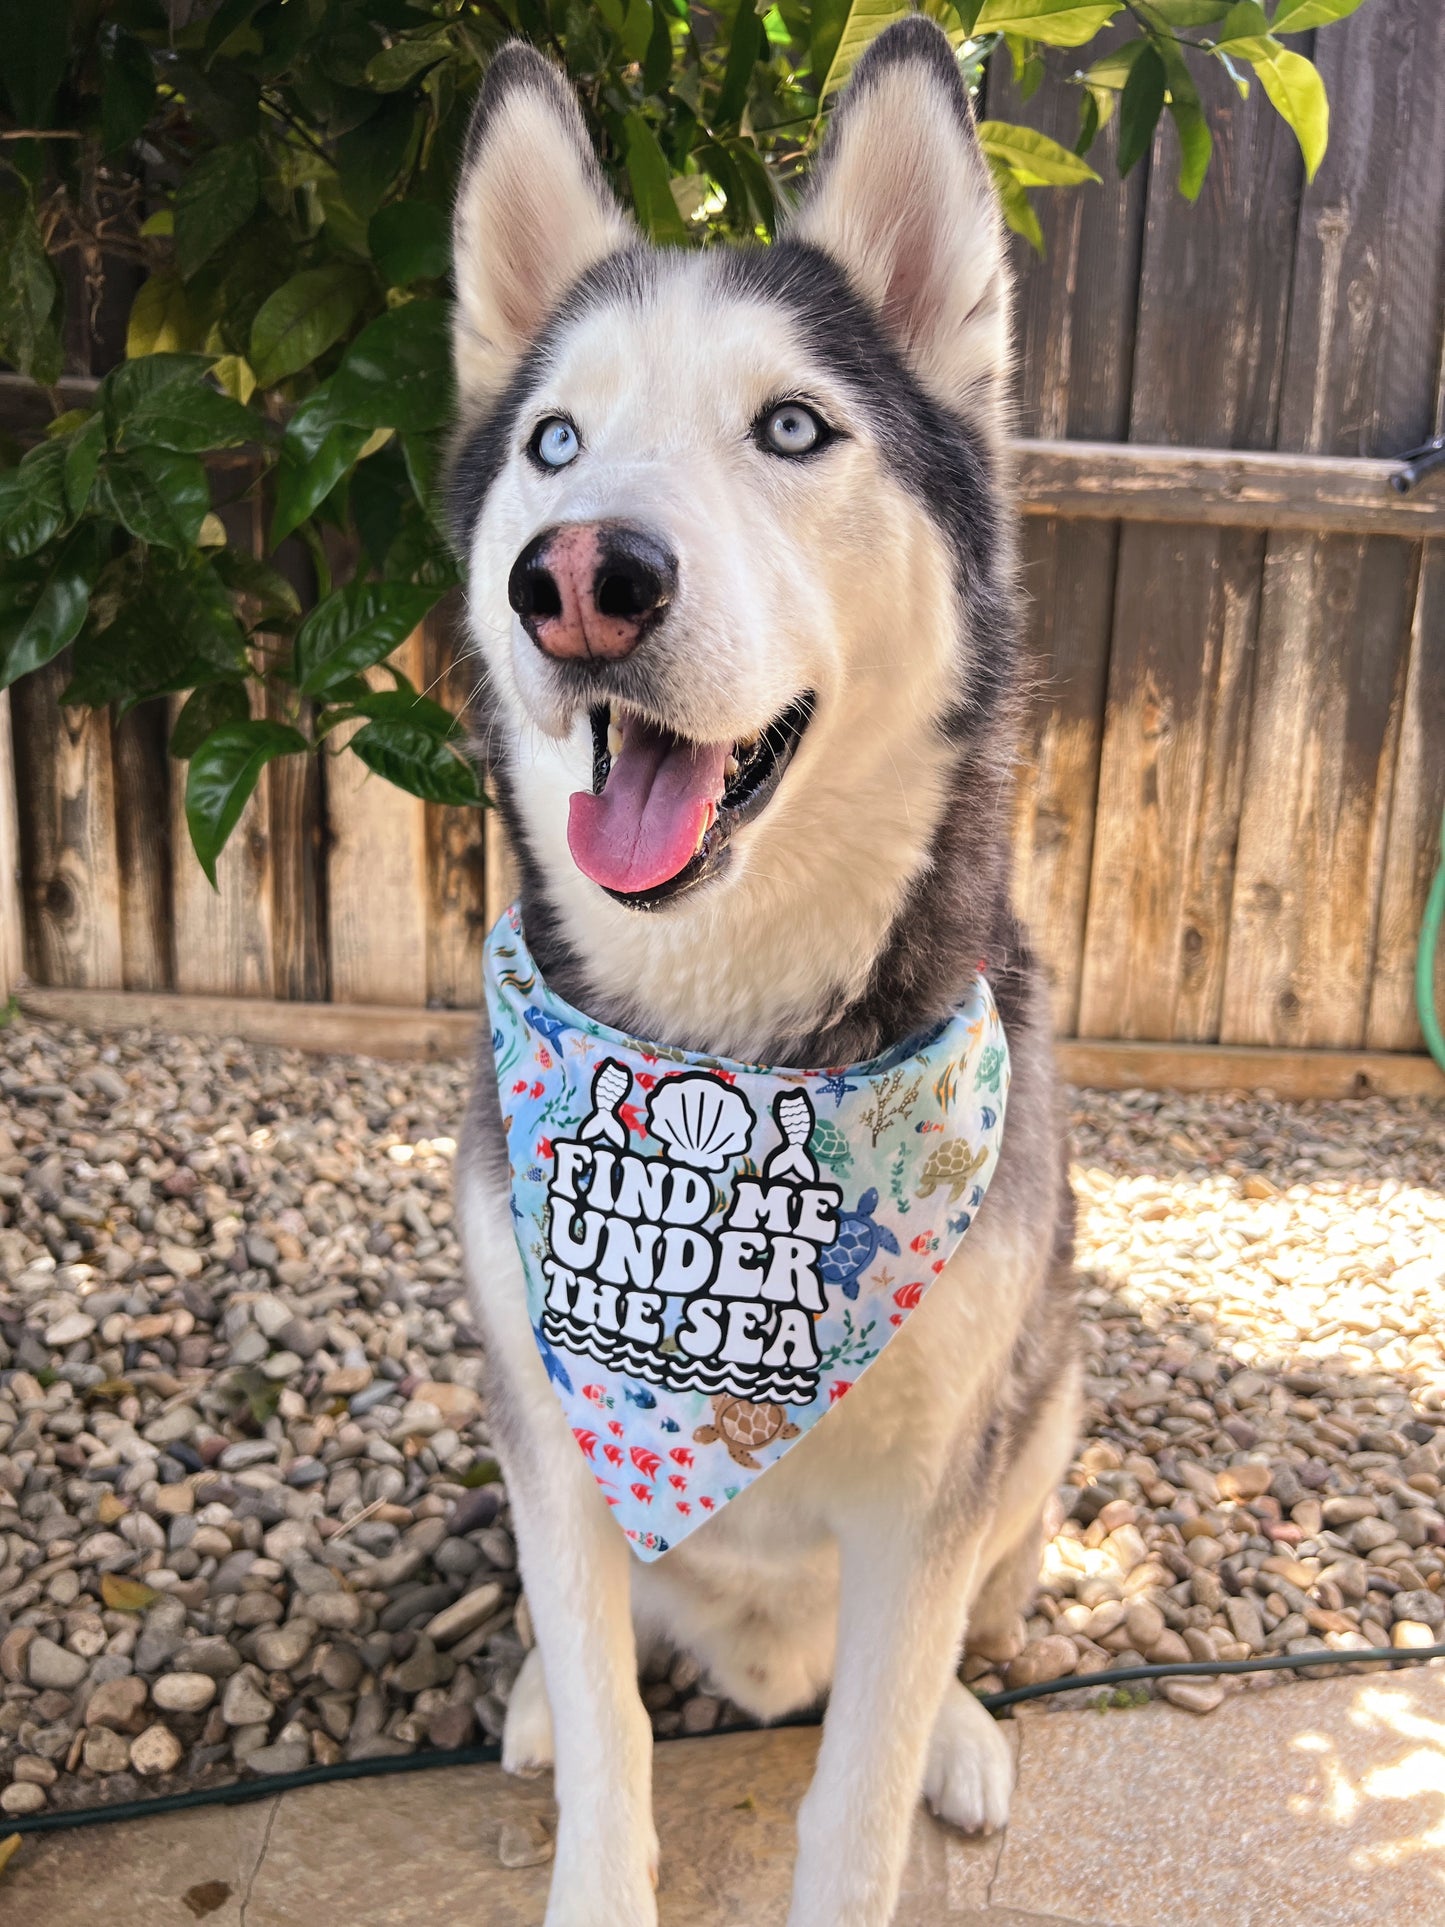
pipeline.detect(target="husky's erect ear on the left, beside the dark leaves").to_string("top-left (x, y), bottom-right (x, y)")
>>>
top-left (453, 40), bottom-right (638, 407)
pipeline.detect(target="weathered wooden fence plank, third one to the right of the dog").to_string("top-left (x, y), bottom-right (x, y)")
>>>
top-left (1220, 4), bottom-right (1445, 1046)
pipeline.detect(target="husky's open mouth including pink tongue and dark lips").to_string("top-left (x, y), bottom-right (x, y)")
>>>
top-left (566, 694), bottom-right (813, 910)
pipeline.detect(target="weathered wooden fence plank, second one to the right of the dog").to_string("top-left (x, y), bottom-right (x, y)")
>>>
top-left (1079, 75), bottom-right (1302, 1039)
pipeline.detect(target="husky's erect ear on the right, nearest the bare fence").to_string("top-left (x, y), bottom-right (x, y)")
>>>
top-left (792, 15), bottom-right (1010, 407)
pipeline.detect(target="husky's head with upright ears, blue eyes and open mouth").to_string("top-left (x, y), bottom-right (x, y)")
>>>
top-left (453, 19), bottom-right (1008, 940)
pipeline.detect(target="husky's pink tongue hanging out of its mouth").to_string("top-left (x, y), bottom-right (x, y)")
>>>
top-left (566, 719), bottom-right (730, 894)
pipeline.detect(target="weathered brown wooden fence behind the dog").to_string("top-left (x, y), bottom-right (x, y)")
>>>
top-left (0, 0), bottom-right (1445, 1089)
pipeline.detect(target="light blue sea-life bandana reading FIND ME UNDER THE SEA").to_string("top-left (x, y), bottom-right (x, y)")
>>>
top-left (486, 908), bottom-right (1010, 1559)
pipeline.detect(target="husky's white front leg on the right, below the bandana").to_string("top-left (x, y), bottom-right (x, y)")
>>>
top-left (788, 1511), bottom-right (988, 1927)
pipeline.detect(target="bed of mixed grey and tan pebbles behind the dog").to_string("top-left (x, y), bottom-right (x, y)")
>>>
top-left (0, 1019), bottom-right (1445, 1815)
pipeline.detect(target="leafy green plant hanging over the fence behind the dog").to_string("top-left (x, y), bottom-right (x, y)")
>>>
top-left (0, 0), bottom-right (1362, 881)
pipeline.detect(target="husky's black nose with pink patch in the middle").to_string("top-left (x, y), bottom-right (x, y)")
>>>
top-left (507, 522), bottom-right (678, 661)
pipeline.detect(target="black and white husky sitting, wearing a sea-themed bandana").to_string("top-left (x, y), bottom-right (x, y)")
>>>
top-left (453, 17), bottom-right (1079, 1927)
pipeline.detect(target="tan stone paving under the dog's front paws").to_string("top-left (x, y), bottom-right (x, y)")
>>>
top-left (11, 1669), bottom-right (1445, 1927)
